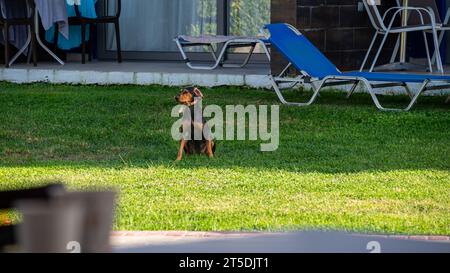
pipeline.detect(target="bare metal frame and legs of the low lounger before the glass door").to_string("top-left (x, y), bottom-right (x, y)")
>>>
top-left (174, 37), bottom-right (270, 70)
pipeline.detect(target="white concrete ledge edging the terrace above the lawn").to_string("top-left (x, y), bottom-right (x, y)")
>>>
top-left (0, 68), bottom-right (449, 95)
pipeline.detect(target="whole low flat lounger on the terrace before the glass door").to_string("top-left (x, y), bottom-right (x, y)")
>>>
top-left (174, 35), bottom-right (270, 70)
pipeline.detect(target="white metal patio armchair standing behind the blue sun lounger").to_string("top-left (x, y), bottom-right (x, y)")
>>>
top-left (360, 0), bottom-right (444, 73)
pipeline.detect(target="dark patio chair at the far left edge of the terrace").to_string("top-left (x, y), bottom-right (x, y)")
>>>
top-left (0, 0), bottom-right (37, 68)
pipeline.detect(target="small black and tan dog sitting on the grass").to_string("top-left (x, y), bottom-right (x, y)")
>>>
top-left (175, 87), bottom-right (216, 161)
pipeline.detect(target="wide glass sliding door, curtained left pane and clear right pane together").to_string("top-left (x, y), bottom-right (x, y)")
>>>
top-left (99, 0), bottom-right (270, 60)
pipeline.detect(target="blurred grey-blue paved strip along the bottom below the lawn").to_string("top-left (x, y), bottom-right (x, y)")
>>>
top-left (111, 231), bottom-right (450, 253)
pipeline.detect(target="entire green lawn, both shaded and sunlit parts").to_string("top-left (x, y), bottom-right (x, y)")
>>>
top-left (0, 83), bottom-right (450, 235)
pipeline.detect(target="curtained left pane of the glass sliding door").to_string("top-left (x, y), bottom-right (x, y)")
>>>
top-left (106, 0), bottom-right (217, 52)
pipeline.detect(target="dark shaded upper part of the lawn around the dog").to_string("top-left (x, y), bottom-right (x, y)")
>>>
top-left (0, 83), bottom-right (450, 173)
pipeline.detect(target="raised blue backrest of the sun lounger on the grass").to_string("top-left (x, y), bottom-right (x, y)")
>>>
top-left (264, 23), bottom-right (341, 78)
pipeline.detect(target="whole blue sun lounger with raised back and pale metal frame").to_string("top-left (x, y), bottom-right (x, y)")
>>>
top-left (264, 23), bottom-right (450, 111)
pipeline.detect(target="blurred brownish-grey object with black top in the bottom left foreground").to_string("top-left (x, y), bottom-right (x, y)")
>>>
top-left (0, 185), bottom-right (116, 253)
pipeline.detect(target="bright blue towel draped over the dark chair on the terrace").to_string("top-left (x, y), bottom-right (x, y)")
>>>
top-left (45, 0), bottom-right (97, 50)
